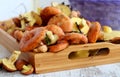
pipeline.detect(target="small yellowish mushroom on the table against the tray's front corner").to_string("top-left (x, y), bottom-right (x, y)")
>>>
top-left (21, 64), bottom-right (34, 75)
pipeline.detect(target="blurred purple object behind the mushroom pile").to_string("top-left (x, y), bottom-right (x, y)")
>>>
top-left (69, 0), bottom-right (120, 30)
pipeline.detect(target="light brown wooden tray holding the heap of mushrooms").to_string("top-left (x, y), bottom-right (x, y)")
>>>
top-left (0, 29), bottom-right (120, 73)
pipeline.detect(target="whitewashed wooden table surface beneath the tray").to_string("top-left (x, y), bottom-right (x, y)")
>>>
top-left (0, 45), bottom-right (120, 77)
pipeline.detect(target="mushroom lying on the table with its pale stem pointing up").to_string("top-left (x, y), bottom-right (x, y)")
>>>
top-left (2, 51), bottom-right (21, 72)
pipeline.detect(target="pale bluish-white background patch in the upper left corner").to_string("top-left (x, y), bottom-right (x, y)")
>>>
top-left (0, 0), bottom-right (33, 20)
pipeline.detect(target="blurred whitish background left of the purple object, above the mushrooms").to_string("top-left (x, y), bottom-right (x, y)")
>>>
top-left (0, 0), bottom-right (69, 21)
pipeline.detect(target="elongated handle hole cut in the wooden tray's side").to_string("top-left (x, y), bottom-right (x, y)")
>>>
top-left (68, 48), bottom-right (110, 59)
